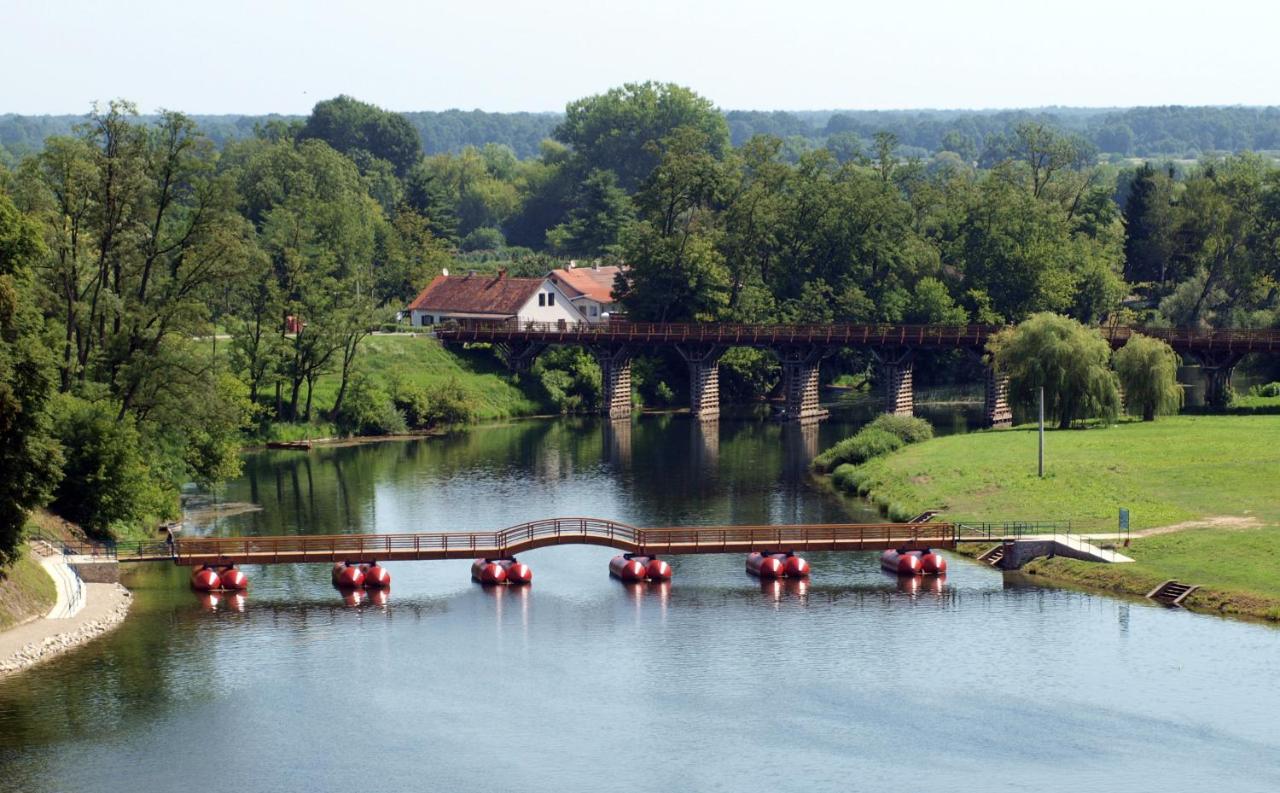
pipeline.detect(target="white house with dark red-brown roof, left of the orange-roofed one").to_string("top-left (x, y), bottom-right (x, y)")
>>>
top-left (408, 270), bottom-right (586, 327)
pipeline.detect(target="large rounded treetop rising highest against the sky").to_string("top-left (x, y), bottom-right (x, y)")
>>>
top-left (556, 82), bottom-right (730, 191)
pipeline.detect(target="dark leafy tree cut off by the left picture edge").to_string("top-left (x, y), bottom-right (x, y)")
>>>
top-left (0, 193), bottom-right (63, 565)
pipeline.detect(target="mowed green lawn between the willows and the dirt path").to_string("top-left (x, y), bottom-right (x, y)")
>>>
top-left (863, 416), bottom-right (1280, 531)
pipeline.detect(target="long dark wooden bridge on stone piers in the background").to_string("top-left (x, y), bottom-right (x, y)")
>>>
top-left (435, 320), bottom-right (1280, 425)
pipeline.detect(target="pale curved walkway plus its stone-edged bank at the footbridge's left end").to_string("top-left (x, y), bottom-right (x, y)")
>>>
top-left (0, 544), bottom-right (132, 677)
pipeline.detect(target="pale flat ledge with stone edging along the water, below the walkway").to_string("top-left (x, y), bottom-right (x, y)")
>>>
top-left (0, 583), bottom-right (132, 677)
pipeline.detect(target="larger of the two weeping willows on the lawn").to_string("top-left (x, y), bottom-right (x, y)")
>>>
top-left (987, 312), bottom-right (1120, 430)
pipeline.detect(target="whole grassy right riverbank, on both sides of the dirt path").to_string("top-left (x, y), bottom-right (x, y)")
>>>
top-left (829, 416), bottom-right (1280, 619)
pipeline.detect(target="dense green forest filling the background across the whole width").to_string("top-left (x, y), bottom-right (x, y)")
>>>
top-left (0, 83), bottom-right (1280, 554)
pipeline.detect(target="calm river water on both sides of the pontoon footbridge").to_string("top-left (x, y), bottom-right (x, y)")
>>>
top-left (0, 406), bottom-right (1280, 793)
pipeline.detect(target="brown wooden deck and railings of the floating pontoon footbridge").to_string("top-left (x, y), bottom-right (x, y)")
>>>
top-left (73, 518), bottom-right (960, 565)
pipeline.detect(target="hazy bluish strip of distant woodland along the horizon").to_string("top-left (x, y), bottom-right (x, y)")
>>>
top-left (0, 106), bottom-right (1280, 168)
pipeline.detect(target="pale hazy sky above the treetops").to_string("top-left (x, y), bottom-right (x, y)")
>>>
top-left (0, 0), bottom-right (1280, 114)
